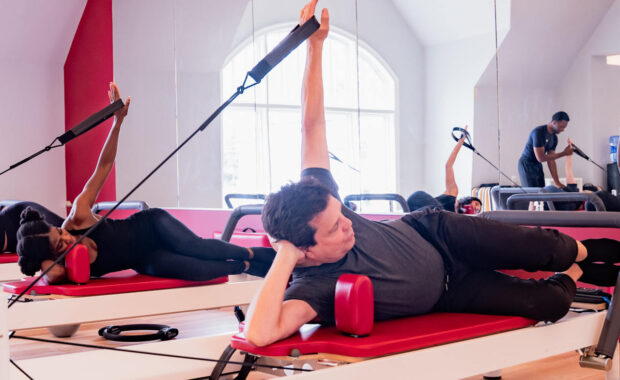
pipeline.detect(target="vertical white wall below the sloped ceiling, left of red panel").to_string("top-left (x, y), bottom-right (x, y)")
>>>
top-left (0, 61), bottom-right (66, 216)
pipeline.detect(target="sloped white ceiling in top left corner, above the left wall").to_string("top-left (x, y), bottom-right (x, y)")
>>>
top-left (0, 0), bottom-right (86, 64)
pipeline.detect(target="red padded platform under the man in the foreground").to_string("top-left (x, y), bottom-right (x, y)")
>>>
top-left (231, 313), bottom-right (536, 357)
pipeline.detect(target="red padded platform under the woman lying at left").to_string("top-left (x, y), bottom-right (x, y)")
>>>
top-left (2, 270), bottom-right (228, 297)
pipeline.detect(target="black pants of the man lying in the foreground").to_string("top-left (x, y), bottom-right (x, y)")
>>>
top-left (403, 210), bottom-right (577, 321)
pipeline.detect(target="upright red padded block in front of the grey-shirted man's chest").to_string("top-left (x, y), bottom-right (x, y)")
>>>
top-left (334, 274), bottom-right (375, 336)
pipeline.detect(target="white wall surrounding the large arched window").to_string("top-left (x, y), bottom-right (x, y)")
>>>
top-left (113, 0), bottom-right (424, 207)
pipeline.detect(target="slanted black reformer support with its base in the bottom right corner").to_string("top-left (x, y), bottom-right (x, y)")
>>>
top-left (579, 274), bottom-right (620, 372)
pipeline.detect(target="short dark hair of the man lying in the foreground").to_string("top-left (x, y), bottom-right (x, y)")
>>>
top-left (262, 178), bottom-right (330, 249)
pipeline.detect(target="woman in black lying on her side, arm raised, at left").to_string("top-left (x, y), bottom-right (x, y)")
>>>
top-left (17, 83), bottom-right (275, 283)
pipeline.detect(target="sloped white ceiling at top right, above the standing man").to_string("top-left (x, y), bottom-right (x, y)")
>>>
top-left (478, 0), bottom-right (614, 88)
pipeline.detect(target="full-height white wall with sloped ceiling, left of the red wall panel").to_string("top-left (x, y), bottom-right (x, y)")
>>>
top-left (0, 0), bottom-right (86, 216)
